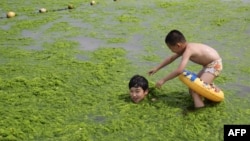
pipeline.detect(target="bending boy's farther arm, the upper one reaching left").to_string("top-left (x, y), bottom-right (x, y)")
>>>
top-left (148, 54), bottom-right (180, 75)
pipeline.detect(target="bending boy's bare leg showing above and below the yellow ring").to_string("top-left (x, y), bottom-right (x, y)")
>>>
top-left (190, 72), bottom-right (215, 108)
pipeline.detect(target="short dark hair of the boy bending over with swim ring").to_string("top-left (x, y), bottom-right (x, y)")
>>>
top-left (165, 30), bottom-right (186, 46)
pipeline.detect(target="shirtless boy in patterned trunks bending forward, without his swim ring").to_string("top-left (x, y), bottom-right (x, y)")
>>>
top-left (148, 30), bottom-right (222, 108)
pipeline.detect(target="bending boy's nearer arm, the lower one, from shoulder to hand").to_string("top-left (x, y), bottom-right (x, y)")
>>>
top-left (156, 53), bottom-right (190, 88)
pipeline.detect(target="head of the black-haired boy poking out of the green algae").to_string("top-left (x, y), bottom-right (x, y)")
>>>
top-left (128, 75), bottom-right (148, 103)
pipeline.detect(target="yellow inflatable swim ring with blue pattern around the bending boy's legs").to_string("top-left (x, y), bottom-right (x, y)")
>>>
top-left (179, 70), bottom-right (224, 102)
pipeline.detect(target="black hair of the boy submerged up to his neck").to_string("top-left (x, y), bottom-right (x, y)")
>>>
top-left (128, 74), bottom-right (148, 91)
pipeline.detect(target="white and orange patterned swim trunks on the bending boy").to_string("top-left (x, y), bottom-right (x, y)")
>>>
top-left (204, 59), bottom-right (223, 76)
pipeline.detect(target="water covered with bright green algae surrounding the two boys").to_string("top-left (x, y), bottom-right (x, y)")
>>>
top-left (0, 0), bottom-right (250, 141)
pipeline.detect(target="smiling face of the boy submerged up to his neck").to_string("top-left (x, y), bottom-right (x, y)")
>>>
top-left (129, 87), bottom-right (148, 103)
